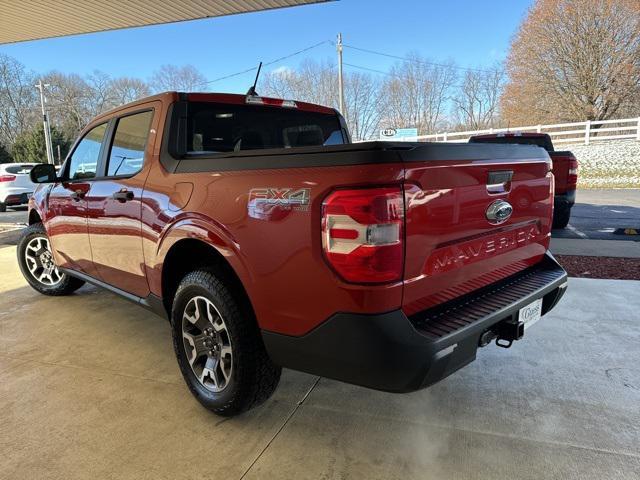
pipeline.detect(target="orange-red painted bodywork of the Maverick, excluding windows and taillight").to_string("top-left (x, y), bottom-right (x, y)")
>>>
top-left (32, 93), bottom-right (553, 336)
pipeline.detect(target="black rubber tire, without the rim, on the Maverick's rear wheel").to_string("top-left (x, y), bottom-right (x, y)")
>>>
top-left (171, 270), bottom-right (282, 416)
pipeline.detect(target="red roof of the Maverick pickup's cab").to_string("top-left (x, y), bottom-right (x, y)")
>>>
top-left (92, 91), bottom-right (338, 123)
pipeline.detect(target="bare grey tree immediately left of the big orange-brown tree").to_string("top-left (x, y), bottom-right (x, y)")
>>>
top-left (452, 66), bottom-right (505, 130)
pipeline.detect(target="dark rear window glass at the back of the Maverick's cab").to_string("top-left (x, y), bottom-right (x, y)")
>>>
top-left (186, 102), bottom-right (345, 154)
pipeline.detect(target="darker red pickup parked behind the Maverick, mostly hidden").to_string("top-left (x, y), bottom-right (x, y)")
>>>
top-left (469, 132), bottom-right (578, 228)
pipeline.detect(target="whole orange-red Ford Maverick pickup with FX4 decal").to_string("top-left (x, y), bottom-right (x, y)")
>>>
top-left (17, 92), bottom-right (567, 415)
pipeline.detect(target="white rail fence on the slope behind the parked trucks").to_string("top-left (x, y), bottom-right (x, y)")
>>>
top-left (416, 117), bottom-right (640, 145)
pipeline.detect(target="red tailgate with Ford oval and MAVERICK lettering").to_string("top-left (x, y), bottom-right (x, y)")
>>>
top-left (399, 144), bottom-right (553, 315)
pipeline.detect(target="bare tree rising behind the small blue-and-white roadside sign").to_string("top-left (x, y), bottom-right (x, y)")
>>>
top-left (381, 53), bottom-right (457, 134)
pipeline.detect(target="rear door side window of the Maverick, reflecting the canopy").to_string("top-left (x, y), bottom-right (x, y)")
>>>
top-left (107, 111), bottom-right (153, 177)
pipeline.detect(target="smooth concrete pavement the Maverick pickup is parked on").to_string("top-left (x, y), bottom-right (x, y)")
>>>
top-left (0, 247), bottom-right (640, 480)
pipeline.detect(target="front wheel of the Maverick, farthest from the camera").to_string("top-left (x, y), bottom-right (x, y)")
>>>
top-left (17, 223), bottom-right (84, 296)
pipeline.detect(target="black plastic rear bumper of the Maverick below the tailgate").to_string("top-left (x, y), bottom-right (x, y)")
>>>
top-left (262, 254), bottom-right (567, 392)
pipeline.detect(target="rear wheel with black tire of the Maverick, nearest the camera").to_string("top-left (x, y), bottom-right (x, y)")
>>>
top-left (171, 270), bottom-right (281, 416)
